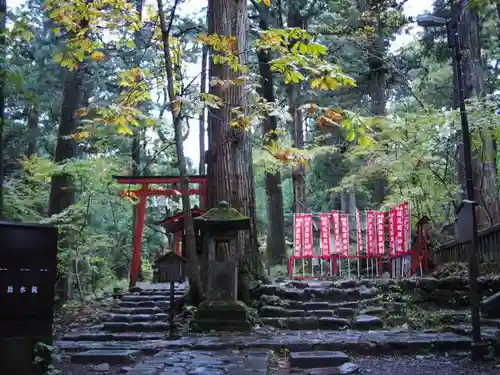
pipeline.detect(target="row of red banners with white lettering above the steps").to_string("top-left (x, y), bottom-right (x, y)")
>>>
top-left (293, 202), bottom-right (411, 257)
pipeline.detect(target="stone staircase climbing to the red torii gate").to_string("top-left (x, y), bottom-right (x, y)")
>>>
top-left (56, 284), bottom-right (187, 363)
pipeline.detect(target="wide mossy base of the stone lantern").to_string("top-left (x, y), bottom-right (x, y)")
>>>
top-left (190, 301), bottom-right (252, 332)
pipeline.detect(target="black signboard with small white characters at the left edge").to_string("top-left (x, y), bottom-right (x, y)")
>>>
top-left (0, 221), bottom-right (58, 338)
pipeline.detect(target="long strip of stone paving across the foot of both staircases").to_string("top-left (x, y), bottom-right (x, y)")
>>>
top-left (55, 330), bottom-right (471, 355)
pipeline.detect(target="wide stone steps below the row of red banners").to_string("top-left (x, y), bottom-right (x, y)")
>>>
top-left (255, 280), bottom-right (398, 331)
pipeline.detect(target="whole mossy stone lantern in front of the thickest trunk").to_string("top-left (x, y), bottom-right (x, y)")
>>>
top-left (192, 202), bottom-right (251, 331)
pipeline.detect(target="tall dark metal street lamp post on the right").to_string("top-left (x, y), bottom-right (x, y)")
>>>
top-left (416, 0), bottom-right (484, 360)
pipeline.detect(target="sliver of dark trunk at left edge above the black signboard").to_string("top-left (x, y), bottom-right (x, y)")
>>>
top-left (0, 0), bottom-right (7, 220)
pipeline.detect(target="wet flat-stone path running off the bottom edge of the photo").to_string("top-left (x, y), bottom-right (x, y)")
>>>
top-left (127, 350), bottom-right (270, 375)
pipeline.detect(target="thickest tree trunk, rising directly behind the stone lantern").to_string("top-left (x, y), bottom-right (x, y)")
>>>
top-left (207, 0), bottom-right (265, 302)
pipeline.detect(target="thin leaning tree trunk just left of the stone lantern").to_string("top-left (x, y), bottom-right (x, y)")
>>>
top-left (157, 0), bottom-right (203, 305)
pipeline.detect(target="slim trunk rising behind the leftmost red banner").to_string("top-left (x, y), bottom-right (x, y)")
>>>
top-left (287, 1), bottom-right (307, 213)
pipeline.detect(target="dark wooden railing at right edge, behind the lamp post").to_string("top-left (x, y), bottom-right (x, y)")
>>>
top-left (432, 224), bottom-right (500, 265)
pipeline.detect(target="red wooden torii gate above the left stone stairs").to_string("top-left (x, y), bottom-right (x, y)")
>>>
top-left (113, 176), bottom-right (207, 287)
